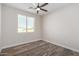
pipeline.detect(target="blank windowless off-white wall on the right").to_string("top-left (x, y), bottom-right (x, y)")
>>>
top-left (43, 4), bottom-right (79, 52)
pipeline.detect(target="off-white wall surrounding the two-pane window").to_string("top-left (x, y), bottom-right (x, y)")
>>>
top-left (2, 6), bottom-right (41, 48)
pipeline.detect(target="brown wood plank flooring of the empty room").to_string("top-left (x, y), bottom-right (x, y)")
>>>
top-left (0, 40), bottom-right (79, 56)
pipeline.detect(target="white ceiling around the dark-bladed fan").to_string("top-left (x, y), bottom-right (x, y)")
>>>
top-left (4, 3), bottom-right (69, 15)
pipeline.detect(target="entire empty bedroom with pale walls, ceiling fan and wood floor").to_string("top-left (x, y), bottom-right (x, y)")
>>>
top-left (0, 3), bottom-right (79, 56)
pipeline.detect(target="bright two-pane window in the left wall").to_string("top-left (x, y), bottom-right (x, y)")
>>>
top-left (18, 15), bottom-right (34, 32)
